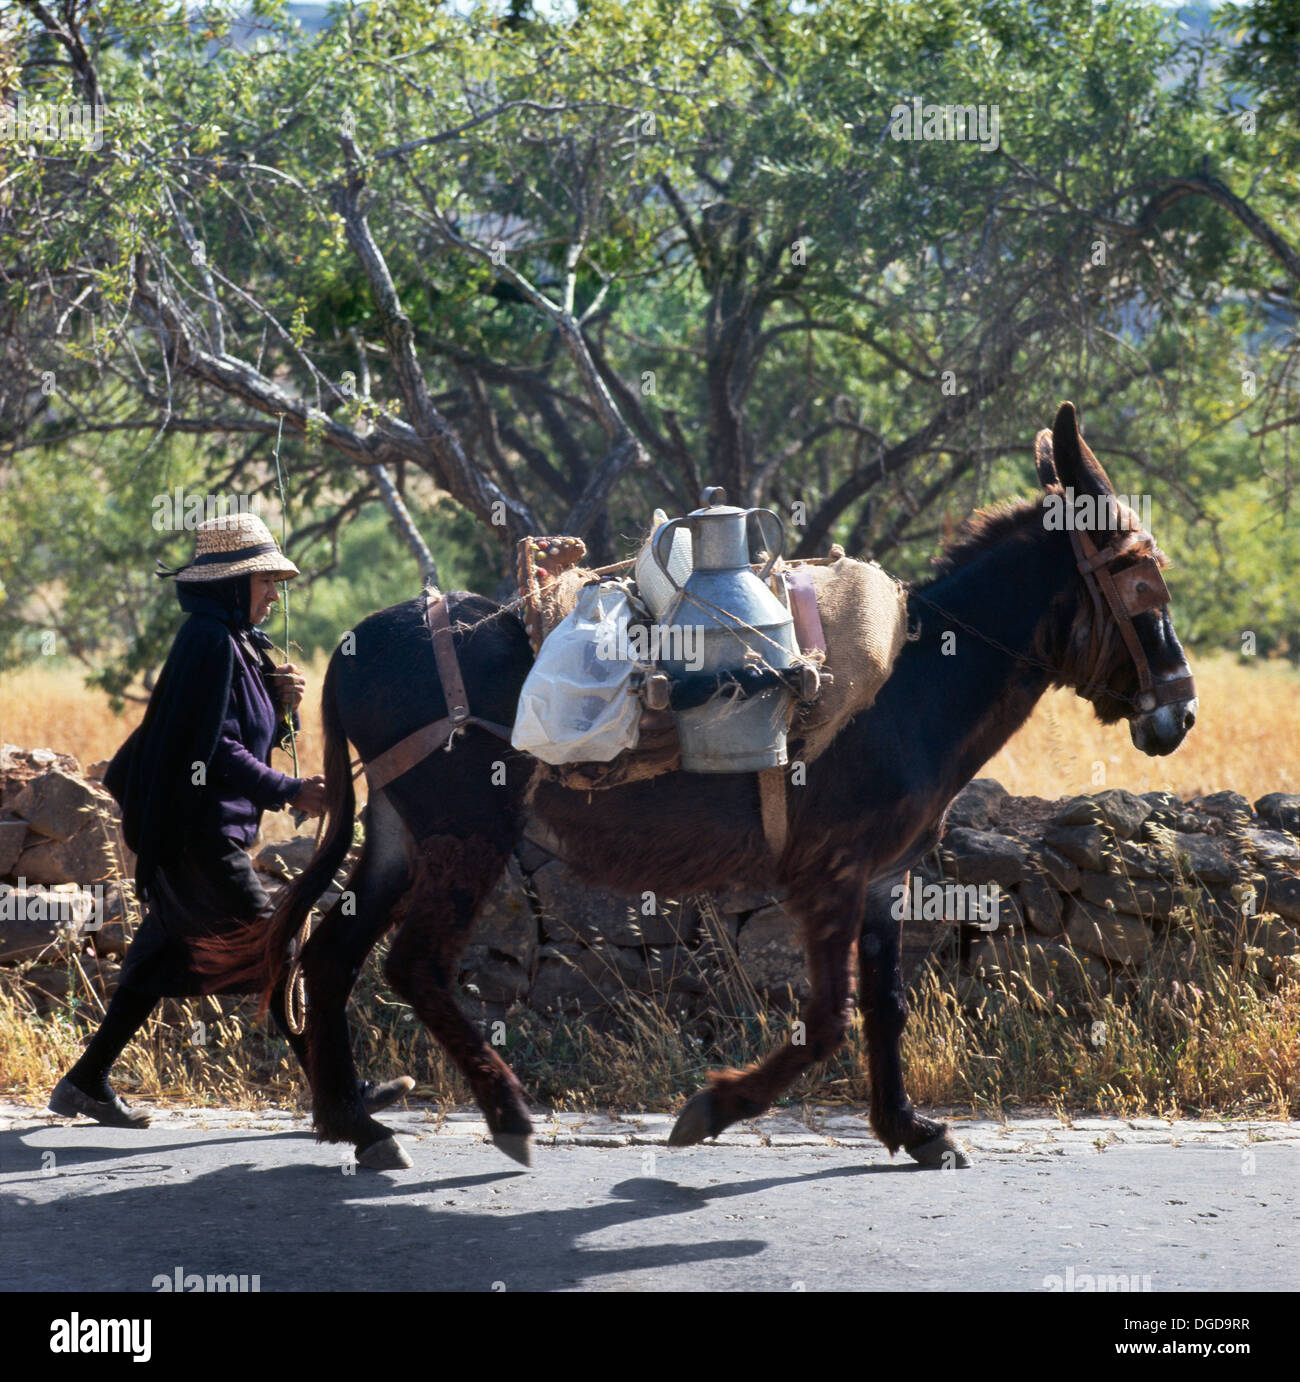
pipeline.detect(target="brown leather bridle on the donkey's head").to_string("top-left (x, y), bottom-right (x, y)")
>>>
top-left (1069, 528), bottom-right (1196, 713)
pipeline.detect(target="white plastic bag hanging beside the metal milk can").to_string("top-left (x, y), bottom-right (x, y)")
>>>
top-left (510, 582), bottom-right (641, 763)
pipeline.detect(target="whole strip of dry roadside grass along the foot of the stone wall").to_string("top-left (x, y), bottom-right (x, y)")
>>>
top-left (0, 862), bottom-right (1300, 1118)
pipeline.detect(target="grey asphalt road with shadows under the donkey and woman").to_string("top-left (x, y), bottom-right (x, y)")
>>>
top-left (0, 1104), bottom-right (1300, 1292)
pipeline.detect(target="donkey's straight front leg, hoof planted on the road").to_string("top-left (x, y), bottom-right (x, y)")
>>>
top-left (858, 869), bottom-right (970, 1168)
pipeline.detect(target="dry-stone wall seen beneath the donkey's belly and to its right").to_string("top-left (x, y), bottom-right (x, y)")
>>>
top-left (461, 778), bottom-right (1300, 1016)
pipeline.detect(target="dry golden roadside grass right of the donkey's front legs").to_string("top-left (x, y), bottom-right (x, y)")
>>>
top-left (895, 914), bottom-right (1300, 1119)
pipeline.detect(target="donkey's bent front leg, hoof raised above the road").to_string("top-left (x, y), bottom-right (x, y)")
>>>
top-left (669, 886), bottom-right (861, 1147)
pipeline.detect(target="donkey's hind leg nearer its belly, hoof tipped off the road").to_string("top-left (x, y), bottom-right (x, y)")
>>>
top-left (385, 835), bottom-right (533, 1166)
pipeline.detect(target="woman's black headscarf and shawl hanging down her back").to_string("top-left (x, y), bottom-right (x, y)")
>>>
top-left (104, 575), bottom-right (287, 896)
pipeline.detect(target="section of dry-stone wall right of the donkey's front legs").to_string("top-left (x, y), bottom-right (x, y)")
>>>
top-left (905, 778), bottom-right (1300, 1005)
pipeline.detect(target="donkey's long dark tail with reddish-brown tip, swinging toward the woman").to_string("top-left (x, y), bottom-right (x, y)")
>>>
top-left (193, 652), bottom-right (356, 1012)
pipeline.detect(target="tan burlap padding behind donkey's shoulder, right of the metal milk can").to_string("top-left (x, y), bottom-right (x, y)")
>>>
top-left (790, 557), bottom-right (908, 763)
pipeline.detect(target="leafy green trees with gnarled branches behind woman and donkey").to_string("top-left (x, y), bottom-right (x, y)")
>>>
top-left (0, 0), bottom-right (1293, 685)
